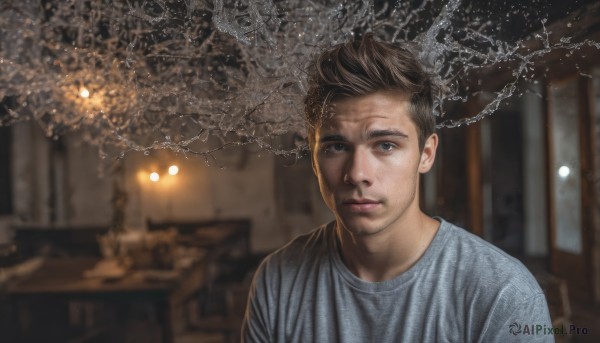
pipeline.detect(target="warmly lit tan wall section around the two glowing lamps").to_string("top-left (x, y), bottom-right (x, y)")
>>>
top-left (124, 144), bottom-right (286, 251)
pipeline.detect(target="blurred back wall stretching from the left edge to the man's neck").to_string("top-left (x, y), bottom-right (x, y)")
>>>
top-left (7, 123), bottom-right (332, 252)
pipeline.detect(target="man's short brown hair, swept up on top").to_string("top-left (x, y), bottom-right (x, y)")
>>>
top-left (304, 34), bottom-right (435, 150)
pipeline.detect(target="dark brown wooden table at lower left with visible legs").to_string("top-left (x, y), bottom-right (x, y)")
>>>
top-left (6, 257), bottom-right (207, 343)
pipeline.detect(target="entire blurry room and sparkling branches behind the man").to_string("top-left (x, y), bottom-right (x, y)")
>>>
top-left (0, 0), bottom-right (600, 342)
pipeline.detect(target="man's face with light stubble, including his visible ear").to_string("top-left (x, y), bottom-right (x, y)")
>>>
top-left (313, 92), bottom-right (437, 235)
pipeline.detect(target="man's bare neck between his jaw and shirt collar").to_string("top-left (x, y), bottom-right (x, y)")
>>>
top-left (336, 211), bottom-right (440, 282)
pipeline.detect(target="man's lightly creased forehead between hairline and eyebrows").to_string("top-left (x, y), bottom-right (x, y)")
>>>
top-left (319, 92), bottom-right (416, 131)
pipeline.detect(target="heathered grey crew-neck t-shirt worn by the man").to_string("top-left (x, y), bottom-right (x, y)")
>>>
top-left (242, 219), bottom-right (554, 343)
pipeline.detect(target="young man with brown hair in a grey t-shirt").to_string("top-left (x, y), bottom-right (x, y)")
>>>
top-left (242, 35), bottom-right (554, 343)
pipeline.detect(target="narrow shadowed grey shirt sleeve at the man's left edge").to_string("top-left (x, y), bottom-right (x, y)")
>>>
top-left (241, 262), bottom-right (273, 343)
